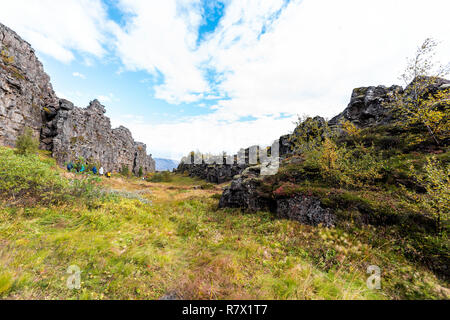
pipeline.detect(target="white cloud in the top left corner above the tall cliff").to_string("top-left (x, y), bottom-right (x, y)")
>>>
top-left (0, 0), bottom-right (115, 63)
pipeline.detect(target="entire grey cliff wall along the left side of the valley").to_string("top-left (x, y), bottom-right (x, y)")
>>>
top-left (0, 24), bottom-right (155, 174)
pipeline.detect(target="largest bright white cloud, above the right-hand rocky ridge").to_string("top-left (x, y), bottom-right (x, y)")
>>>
top-left (200, 0), bottom-right (450, 117)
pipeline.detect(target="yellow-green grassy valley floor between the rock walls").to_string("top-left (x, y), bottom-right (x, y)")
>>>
top-left (0, 148), bottom-right (448, 299)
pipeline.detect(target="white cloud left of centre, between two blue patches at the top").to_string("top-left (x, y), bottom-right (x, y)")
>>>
top-left (116, 0), bottom-right (209, 103)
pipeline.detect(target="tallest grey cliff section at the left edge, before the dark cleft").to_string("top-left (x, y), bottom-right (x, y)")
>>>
top-left (0, 24), bottom-right (59, 146)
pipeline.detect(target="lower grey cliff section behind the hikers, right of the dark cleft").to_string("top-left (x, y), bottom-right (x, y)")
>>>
top-left (53, 100), bottom-right (155, 174)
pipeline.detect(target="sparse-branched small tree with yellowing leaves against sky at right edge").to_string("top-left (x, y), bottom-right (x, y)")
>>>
top-left (387, 39), bottom-right (450, 145)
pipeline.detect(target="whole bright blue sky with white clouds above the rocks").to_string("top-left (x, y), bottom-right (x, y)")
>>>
top-left (0, 0), bottom-right (450, 160)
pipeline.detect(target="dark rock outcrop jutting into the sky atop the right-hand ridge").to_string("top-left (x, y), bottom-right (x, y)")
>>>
top-left (328, 86), bottom-right (403, 128)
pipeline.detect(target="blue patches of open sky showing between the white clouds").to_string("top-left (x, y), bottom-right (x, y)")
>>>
top-left (42, 0), bottom-right (230, 124)
